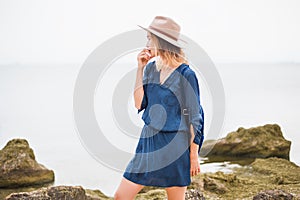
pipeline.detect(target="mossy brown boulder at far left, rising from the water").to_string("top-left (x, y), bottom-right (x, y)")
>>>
top-left (0, 139), bottom-right (54, 188)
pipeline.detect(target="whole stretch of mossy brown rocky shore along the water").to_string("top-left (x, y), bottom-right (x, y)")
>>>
top-left (0, 124), bottom-right (300, 200)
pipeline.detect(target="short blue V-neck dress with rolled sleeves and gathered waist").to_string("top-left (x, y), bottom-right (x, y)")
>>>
top-left (123, 61), bottom-right (204, 187)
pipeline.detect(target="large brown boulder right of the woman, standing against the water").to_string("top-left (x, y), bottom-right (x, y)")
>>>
top-left (201, 124), bottom-right (291, 160)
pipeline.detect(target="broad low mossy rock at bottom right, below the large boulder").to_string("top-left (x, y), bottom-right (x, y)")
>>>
top-left (197, 158), bottom-right (300, 199)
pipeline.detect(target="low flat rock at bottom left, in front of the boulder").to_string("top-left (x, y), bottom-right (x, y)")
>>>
top-left (6, 186), bottom-right (112, 200)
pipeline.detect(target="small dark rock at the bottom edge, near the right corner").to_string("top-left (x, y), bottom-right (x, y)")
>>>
top-left (253, 190), bottom-right (294, 200)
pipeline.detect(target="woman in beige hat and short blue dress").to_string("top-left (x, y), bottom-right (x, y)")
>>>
top-left (115, 16), bottom-right (204, 200)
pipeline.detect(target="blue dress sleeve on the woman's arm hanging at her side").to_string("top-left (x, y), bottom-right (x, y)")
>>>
top-left (184, 70), bottom-right (204, 151)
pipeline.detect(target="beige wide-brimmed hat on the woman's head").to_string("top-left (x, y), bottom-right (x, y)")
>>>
top-left (138, 16), bottom-right (185, 48)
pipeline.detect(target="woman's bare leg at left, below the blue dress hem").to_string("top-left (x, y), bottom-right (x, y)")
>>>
top-left (114, 177), bottom-right (144, 200)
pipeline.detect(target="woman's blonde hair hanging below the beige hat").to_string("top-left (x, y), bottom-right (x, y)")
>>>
top-left (150, 33), bottom-right (188, 71)
